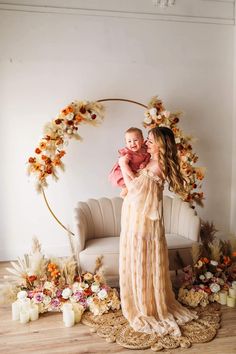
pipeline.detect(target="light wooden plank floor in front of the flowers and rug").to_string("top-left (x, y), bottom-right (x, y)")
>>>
top-left (0, 262), bottom-right (236, 354)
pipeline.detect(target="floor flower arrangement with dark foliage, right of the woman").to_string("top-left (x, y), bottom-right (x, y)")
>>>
top-left (178, 231), bottom-right (236, 307)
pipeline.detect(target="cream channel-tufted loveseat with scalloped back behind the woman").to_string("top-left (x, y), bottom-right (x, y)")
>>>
top-left (72, 196), bottom-right (200, 286)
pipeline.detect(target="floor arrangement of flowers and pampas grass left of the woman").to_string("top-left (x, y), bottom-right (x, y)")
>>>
top-left (0, 239), bottom-right (120, 315)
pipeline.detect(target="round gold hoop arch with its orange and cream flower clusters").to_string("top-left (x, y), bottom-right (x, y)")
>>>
top-left (28, 96), bottom-right (204, 235)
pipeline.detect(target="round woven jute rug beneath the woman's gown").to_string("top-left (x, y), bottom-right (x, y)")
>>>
top-left (82, 303), bottom-right (221, 352)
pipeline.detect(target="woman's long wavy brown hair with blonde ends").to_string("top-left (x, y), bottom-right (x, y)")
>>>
top-left (149, 127), bottom-right (187, 197)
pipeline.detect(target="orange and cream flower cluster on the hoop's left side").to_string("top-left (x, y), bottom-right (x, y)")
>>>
top-left (28, 101), bottom-right (104, 191)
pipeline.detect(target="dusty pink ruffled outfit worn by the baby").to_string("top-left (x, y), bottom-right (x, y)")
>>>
top-left (108, 145), bottom-right (150, 187)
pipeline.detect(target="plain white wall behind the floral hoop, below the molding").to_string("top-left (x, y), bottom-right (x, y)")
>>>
top-left (0, 1), bottom-right (235, 260)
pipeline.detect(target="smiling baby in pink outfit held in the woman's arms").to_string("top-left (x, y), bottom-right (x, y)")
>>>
top-left (109, 127), bottom-right (150, 198)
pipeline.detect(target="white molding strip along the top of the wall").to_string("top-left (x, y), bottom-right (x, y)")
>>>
top-left (0, 0), bottom-right (235, 25)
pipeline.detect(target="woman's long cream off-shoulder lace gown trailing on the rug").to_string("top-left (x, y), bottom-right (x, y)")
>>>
top-left (119, 169), bottom-right (197, 336)
